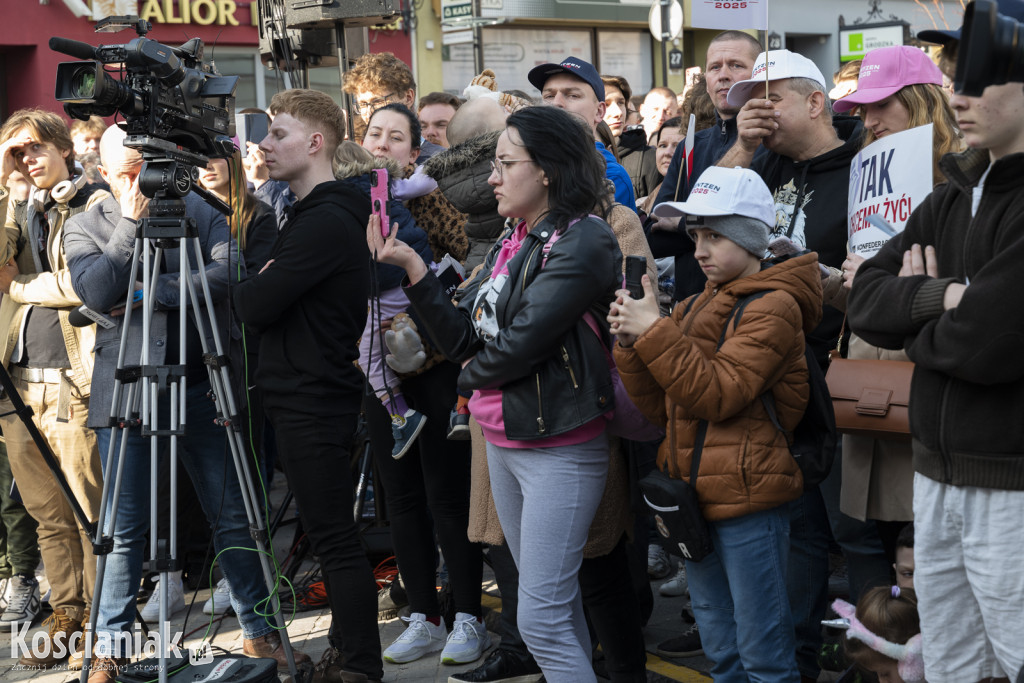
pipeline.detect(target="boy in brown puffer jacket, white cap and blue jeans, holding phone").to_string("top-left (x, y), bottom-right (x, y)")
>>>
top-left (608, 167), bottom-right (821, 683)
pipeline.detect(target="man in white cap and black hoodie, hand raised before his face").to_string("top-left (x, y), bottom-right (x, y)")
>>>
top-left (719, 50), bottom-right (888, 680)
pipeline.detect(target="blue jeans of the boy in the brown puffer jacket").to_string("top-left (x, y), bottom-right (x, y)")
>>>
top-left (686, 505), bottom-right (800, 683)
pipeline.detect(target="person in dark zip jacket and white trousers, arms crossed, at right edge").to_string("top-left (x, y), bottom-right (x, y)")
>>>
top-left (849, 31), bottom-right (1024, 683)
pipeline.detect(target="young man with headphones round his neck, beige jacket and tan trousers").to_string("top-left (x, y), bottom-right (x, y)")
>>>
top-left (0, 110), bottom-right (108, 668)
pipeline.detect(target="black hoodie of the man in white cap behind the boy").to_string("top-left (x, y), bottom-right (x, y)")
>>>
top-left (753, 116), bottom-right (864, 367)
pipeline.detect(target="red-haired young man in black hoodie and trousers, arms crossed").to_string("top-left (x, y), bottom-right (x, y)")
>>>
top-left (234, 89), bottom-right (384, 683)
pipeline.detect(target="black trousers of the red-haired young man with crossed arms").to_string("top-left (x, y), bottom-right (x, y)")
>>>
top-left (267, 407), bottom-right (384, 679)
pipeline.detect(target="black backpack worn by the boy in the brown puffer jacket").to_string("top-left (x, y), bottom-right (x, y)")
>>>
top-left (708, 290), bottom-right (838, 490)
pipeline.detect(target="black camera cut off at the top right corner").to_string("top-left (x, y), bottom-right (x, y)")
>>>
top-left (953, 0), bottom-right (1024, 97)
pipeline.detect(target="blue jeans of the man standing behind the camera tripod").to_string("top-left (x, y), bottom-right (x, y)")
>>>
top-left (96, 381), bottom-right (273, 655)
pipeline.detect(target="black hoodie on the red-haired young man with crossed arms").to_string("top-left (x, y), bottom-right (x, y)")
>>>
top-left (234, 180), bottom-right (370, 415)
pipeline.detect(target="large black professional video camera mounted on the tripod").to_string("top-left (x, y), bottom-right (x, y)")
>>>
top-left (50, 16), bottom-right (239, 180)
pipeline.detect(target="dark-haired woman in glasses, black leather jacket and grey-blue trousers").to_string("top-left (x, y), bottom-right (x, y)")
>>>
top-left (367, 106), bottom-right (622, 682)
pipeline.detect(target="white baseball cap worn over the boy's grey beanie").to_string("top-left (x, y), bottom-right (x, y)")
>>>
top-left (651, 166), bottom-right (775, 225)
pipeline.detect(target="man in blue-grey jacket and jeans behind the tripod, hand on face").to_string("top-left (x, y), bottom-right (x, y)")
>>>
top-left (65, 127), bottom-right (308, 683)
